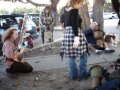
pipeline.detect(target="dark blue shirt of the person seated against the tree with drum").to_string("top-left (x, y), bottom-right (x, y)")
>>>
top-left (84, 28), bottom-right (96, 44)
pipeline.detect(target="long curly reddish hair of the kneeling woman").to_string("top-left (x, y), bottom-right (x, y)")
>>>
top-left (2, 27), bottom-right (17, 42)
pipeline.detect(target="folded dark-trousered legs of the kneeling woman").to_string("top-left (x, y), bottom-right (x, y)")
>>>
top-left (6, 62), bottom-right (33, 73)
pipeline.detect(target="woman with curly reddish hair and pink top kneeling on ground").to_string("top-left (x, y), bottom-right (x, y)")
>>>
top-left (3, 28), bottom-right (33, 73)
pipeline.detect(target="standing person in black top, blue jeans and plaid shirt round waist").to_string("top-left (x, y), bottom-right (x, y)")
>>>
top-left (61, 0), bottom-right (88, 80)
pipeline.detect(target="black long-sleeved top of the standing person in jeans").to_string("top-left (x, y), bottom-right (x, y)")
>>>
top-left (61, 9), bottom-right (82, 36)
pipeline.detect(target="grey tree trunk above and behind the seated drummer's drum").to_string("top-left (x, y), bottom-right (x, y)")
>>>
top-left (93, 0), bottom-right (105, 30)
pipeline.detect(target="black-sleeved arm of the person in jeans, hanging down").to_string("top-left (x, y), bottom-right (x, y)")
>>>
top-left (70, 9), bottom-right (79, 36)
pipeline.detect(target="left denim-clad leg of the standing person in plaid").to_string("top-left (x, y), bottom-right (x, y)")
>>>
top-left (69, 57), bottom-right (78, 80)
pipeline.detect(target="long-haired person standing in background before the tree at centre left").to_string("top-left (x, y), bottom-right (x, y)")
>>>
top-left (40, 6), bottom-right (54, 44)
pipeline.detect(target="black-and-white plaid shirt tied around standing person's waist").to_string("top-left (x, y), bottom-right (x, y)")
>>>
top-left (61, 27), bottom-right (87, 57)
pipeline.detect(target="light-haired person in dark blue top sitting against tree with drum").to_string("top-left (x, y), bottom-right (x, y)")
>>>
top-left (84, 22), bottom-right (115, 54)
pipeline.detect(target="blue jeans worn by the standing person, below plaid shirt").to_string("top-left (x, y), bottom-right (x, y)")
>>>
top-left (69, 53), bottom-right (88, 79)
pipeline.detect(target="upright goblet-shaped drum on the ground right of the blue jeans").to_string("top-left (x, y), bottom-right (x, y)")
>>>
top-left (90, 65), bottom-right (103, 88)
